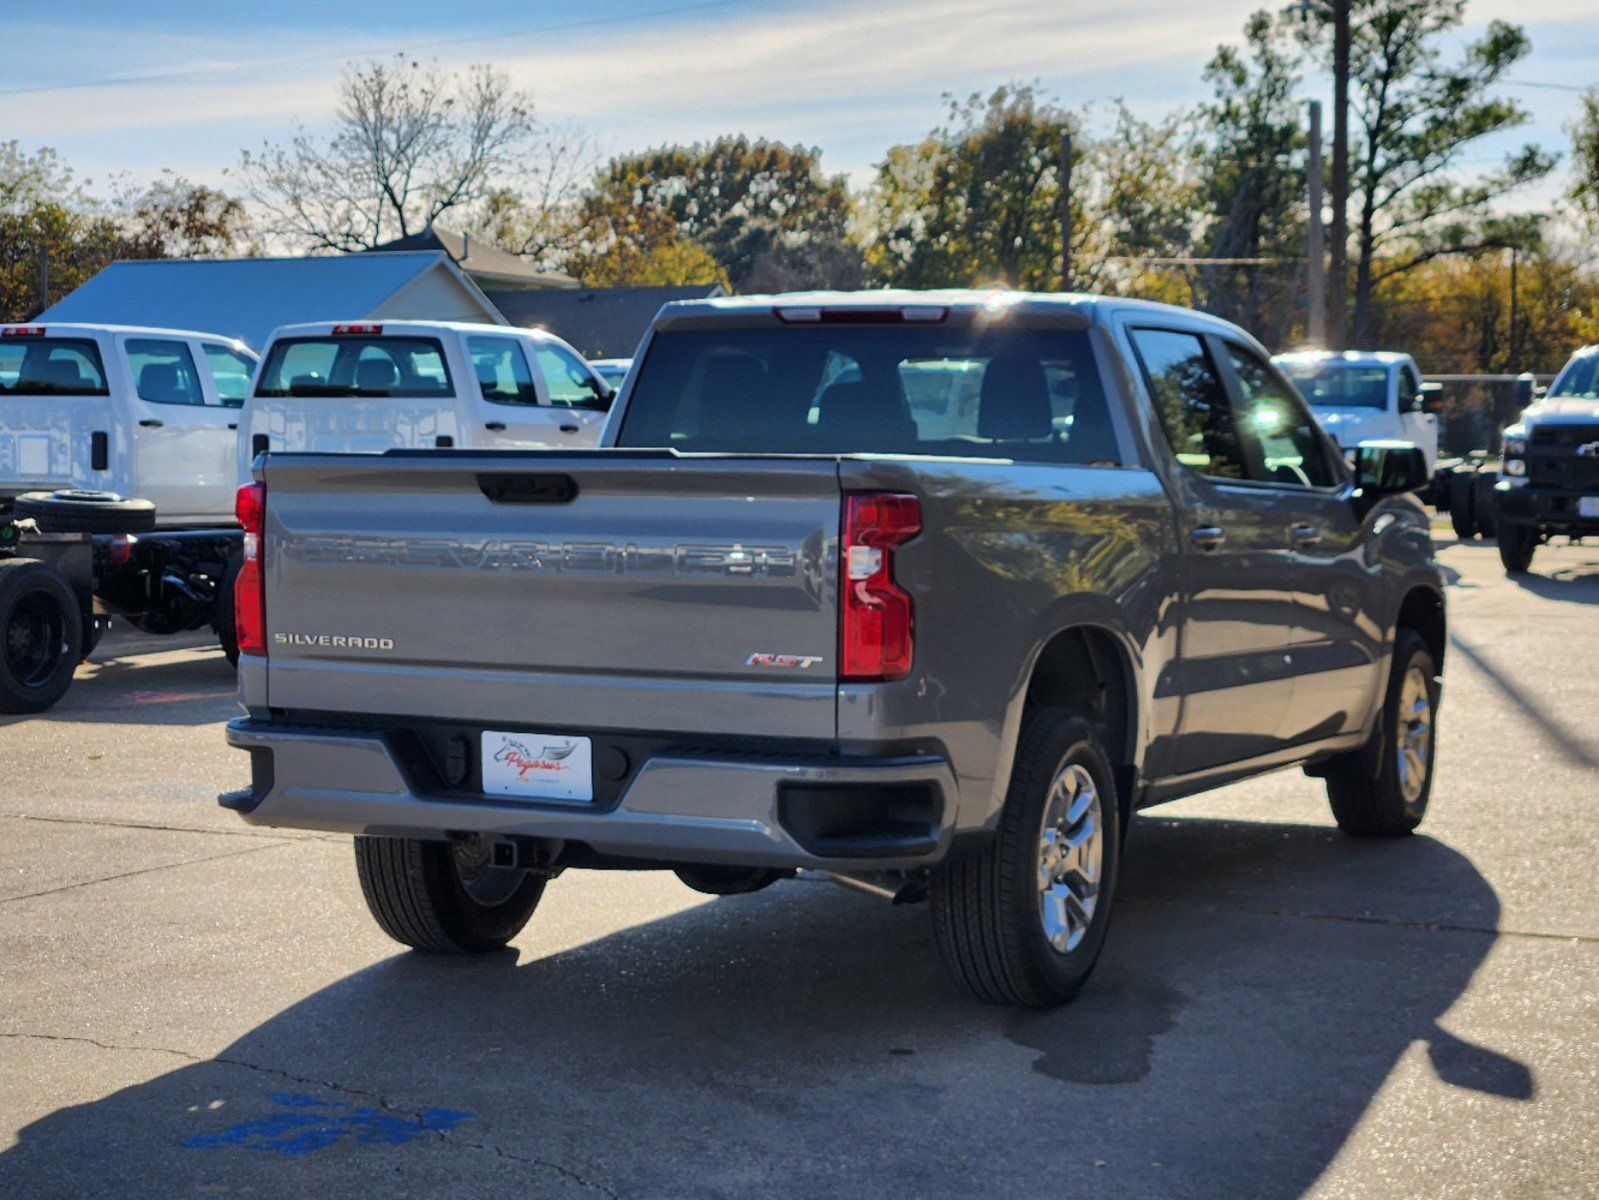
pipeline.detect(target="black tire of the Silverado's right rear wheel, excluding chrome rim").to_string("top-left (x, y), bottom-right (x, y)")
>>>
top-left (927, 707), bottom-right (1122, 1008)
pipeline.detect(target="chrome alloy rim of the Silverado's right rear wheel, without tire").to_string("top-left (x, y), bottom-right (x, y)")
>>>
top-left (1038, 763), bottom-right (1105, 954)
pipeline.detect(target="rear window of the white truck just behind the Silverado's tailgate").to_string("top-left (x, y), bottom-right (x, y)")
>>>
top-left (256, 336), bottom-right (453, 398)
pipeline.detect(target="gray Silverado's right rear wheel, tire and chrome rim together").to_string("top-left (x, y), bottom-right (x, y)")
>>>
top-left (927, 707), bottom-right (1121, 1008)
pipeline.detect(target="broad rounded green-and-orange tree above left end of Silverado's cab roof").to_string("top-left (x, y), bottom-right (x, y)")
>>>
top-left (572, 134), bottom-right (860, 291)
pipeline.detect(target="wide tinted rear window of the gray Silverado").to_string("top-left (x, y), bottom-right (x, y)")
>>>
top-left (617, 325), bottom-right (1121, 464)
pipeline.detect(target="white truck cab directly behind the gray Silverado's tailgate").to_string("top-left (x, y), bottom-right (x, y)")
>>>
top-left (238, 322), bottom-right (616, 480)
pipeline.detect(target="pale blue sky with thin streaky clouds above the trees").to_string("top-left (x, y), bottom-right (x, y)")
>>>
top-left (0, 0), bottom-right (1599, 203)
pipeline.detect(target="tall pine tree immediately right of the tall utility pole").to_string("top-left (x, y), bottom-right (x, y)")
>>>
top-left (1305, 0), bottom-right (1554, 339)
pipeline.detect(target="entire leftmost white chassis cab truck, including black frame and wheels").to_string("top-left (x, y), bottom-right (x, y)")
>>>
top-left (0, 322), bottom-right (256, 712)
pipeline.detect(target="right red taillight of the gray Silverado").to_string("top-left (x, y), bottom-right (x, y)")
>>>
top-left (838, 491), bottom-right (921, 683)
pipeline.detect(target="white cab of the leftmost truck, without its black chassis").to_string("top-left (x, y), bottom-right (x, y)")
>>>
top-left (0, 322), bottom-right (256, 528)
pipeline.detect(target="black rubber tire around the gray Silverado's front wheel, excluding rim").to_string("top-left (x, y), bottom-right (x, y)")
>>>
top-left (1327, 629), bottom-right (1439, 837)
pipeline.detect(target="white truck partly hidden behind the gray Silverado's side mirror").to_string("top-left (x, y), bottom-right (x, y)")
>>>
top-left (1271, 350), bottom-right (1438, 474)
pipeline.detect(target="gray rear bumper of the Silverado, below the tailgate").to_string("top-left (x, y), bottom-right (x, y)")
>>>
top-left (219, 718), bottom-right (956, 870)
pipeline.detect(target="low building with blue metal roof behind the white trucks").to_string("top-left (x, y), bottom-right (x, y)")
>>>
top-left (34, 250), bottom-right (507, 350)
